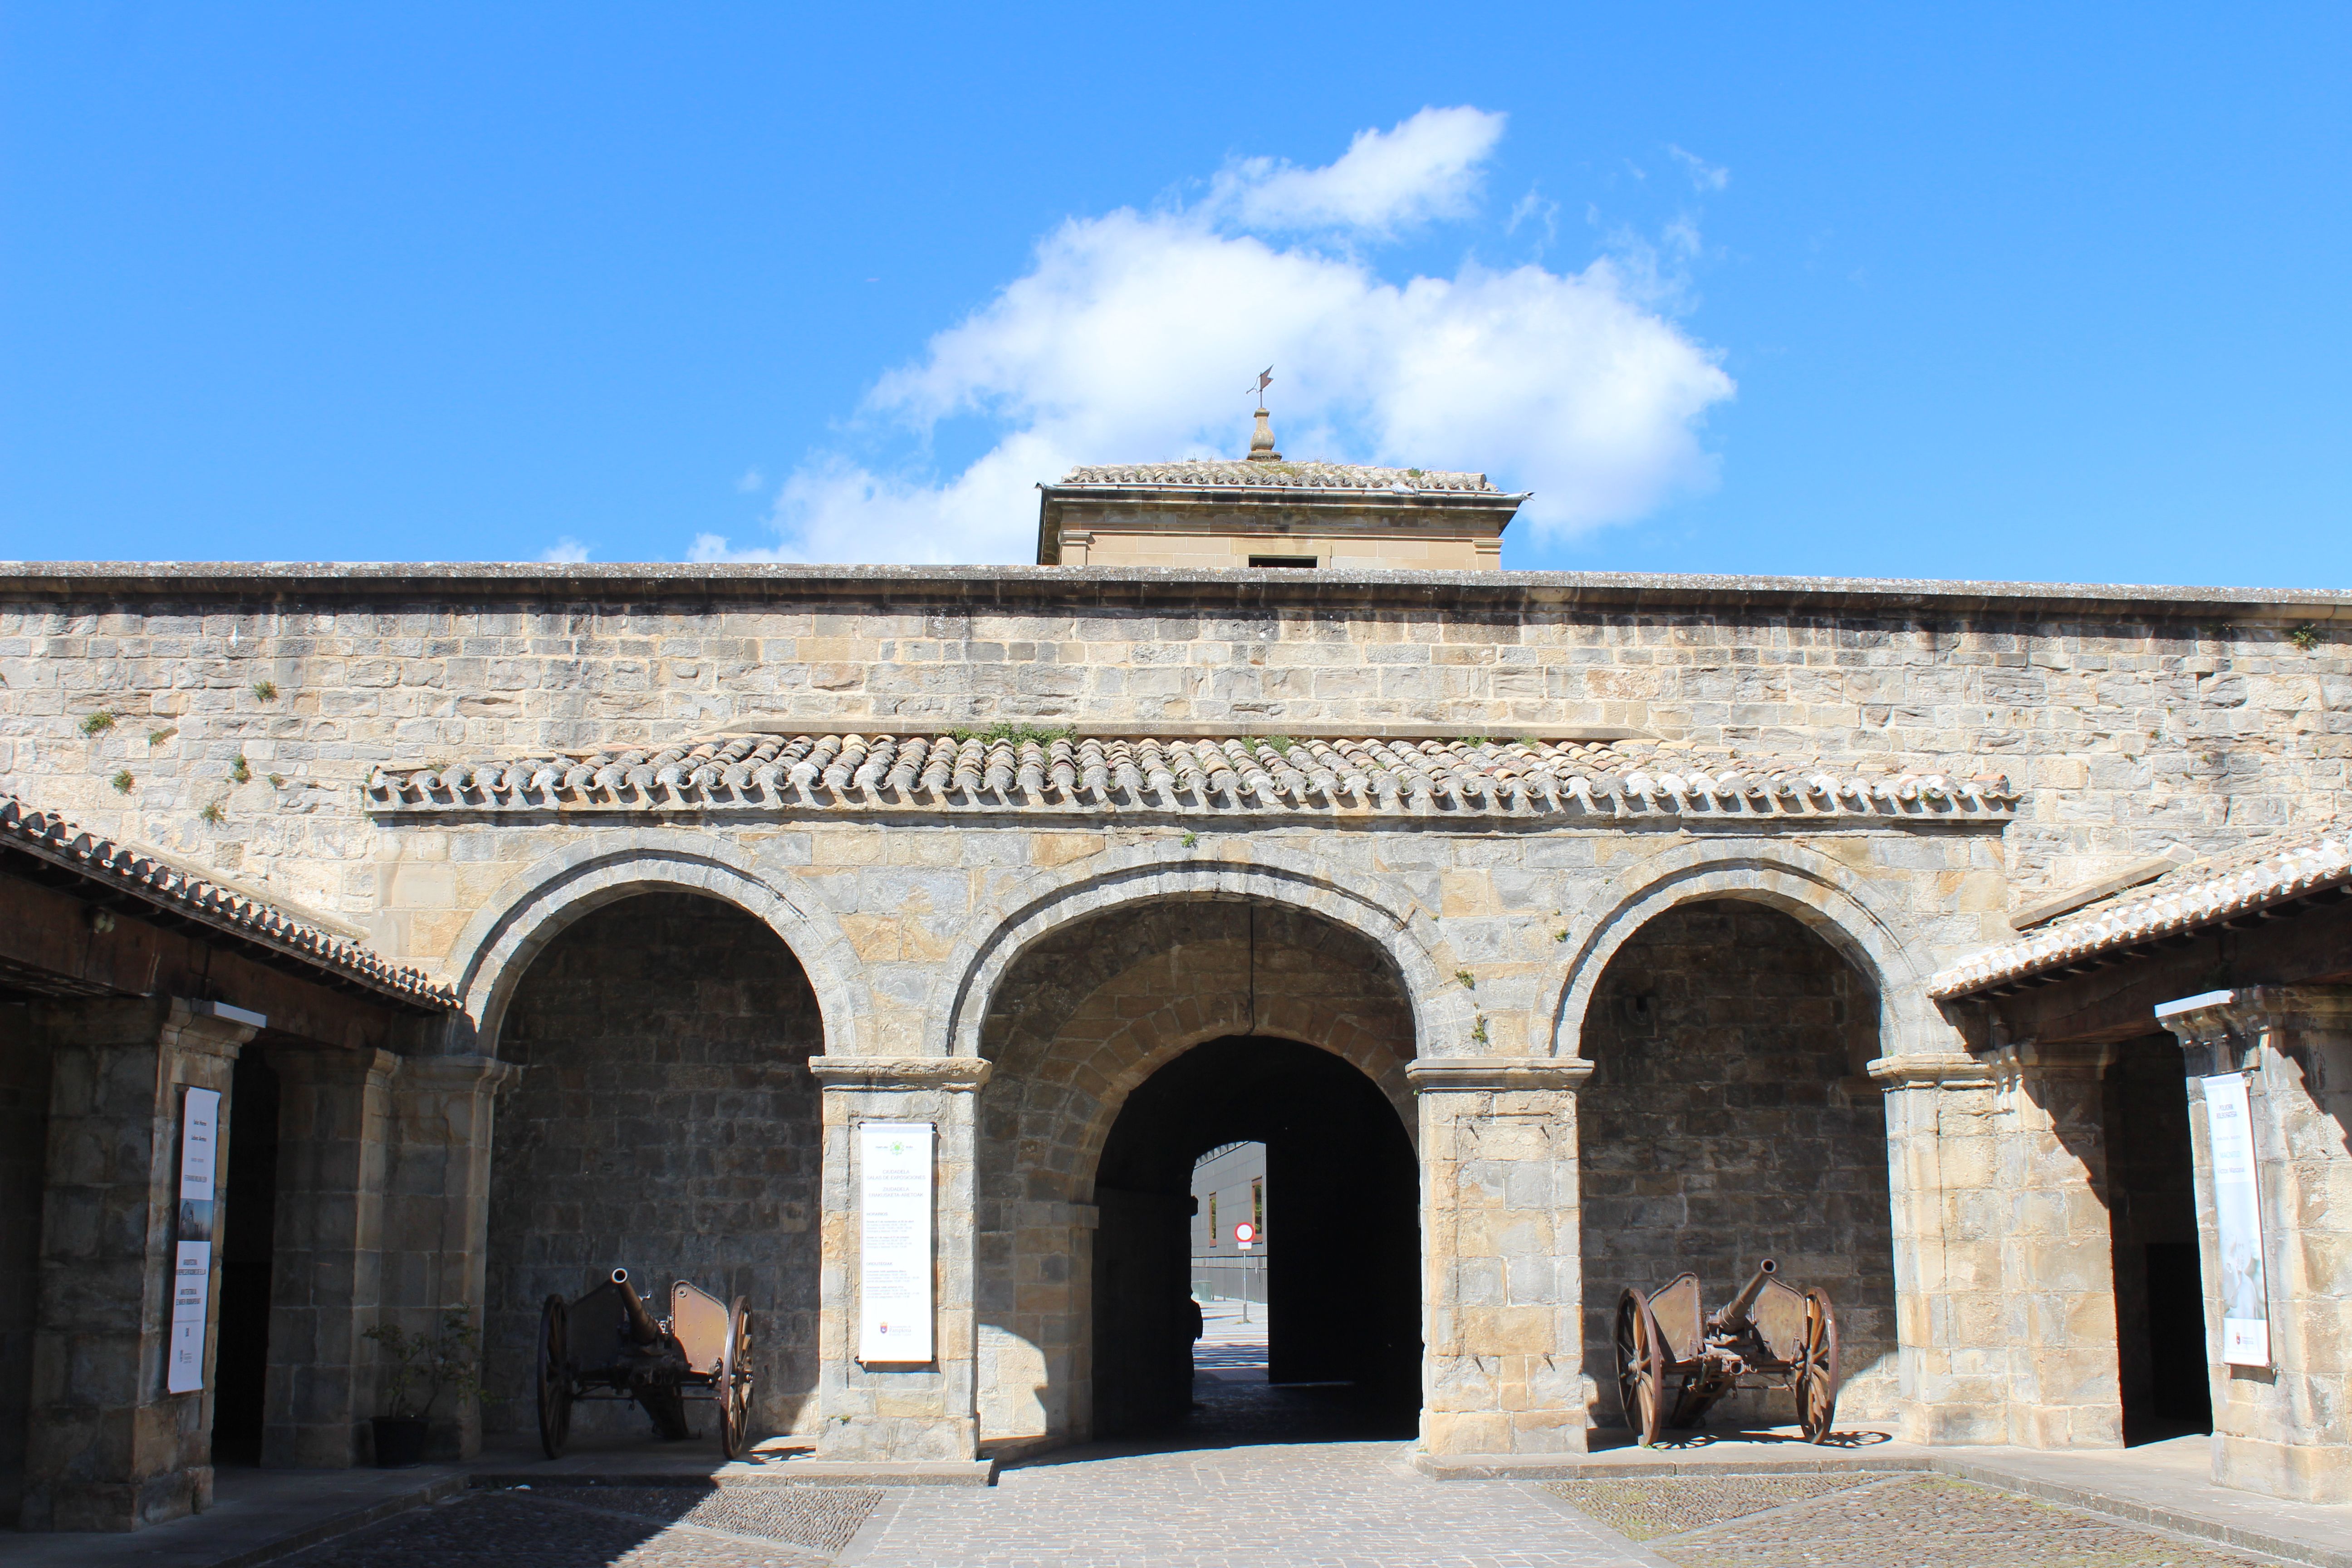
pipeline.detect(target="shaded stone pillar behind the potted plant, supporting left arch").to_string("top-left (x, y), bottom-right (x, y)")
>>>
top-left (378, 1055), bottom-right (520, 1460)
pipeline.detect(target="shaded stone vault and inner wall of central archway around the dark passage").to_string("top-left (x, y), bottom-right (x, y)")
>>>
top-left (974, 893), bottom-right (1418, 1453)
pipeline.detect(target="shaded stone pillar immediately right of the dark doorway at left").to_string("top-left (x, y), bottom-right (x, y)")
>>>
top-left (261, 1049), bottom-right (400, 1469)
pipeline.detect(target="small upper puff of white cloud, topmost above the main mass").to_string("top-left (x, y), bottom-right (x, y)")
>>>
top-left (1204, 108), bottom-right (1503, 235)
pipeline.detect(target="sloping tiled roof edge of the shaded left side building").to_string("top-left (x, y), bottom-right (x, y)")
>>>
top-left (0, 794), bottom-right (459, 1009)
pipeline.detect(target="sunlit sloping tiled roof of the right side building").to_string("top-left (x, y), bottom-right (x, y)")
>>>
top-left (1929, 823), bottom-right (2352, 997)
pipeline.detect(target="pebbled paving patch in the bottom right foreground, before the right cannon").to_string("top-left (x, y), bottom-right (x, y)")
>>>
top-left (1550, 1474), bottom-right (2272, 1568)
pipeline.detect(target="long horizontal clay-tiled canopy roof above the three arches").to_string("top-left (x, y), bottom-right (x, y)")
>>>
top-left (367, 734), bottom-right (2016, 818)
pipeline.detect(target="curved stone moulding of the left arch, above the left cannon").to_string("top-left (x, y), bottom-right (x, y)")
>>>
top-left (451, 828), bottom-right (868, 1053)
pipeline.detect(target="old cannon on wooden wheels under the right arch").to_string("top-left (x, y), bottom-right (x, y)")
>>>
top-left (1616, 1258), bottom-right (1837, 1448)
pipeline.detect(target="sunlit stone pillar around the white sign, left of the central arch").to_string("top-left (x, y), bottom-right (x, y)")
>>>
top-left (809, 1055), bottom-right (988, 1462)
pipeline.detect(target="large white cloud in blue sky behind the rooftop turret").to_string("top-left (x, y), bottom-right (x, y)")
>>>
top-left (691, 108), bottom-right (1734, 562)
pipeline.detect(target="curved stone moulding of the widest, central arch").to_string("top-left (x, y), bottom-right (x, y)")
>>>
top-left (938, 842), bottom-right (1472, 1055)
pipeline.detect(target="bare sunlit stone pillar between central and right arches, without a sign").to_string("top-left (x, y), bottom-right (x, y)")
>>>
top-left (1406, 1058), bottom-right (1592, 1453)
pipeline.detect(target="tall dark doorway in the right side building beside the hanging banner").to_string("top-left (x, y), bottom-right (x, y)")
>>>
top-left (2100, 1034), bottom-right (2213, 1443)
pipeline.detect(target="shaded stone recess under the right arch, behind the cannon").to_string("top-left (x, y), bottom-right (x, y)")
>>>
top-left (1578, 898), bottom-right (1896, 1429)
